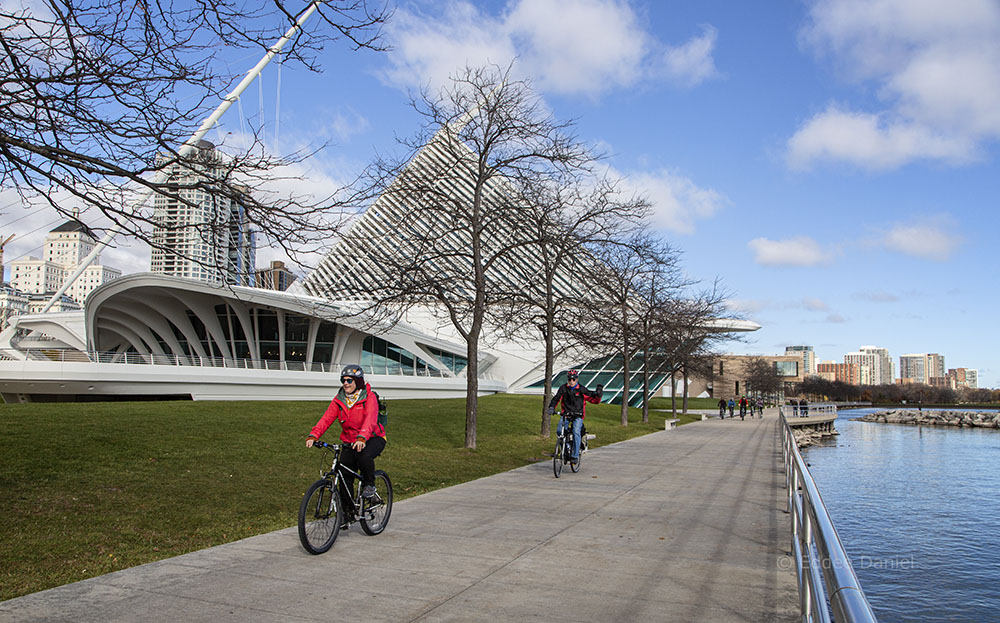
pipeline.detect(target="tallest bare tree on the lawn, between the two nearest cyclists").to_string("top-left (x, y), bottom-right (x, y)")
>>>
top-left (347, 66), bottom-right (593, 448)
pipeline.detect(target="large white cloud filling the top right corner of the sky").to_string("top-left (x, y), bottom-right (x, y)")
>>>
top-left (788, 0), bottom-right (1000, 169)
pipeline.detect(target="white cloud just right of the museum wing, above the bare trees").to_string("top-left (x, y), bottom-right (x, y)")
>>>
top-left (625, 170), bottom-right (726, 234)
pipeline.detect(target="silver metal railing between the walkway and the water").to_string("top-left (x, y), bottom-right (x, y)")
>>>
top-left (781, 416), bottom-right (875, 623)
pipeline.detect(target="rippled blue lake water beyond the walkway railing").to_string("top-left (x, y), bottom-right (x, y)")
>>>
top-left (803, 409), bottom-right (1000, 623)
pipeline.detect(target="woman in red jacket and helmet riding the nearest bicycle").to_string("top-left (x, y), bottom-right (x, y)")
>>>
top-left (306, 365), bottom-right (385, 528)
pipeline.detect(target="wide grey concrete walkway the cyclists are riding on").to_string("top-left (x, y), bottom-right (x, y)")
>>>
top-left (0, 410), bottom-right (798, 623)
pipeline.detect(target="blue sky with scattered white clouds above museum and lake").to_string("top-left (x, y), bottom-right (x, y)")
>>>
top-left (0, 0), bottom-right (1000, 387)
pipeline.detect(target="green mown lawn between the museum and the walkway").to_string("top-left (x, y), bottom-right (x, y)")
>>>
top-left (0, 395), bottom-right (676, 600)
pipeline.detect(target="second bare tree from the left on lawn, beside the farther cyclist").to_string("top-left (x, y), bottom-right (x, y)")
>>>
top-left (512, 175), bottom-right (649, 437)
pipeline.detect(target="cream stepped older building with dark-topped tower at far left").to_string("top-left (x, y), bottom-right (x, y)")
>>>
top-left (10, 221), bottom-right (122, 306)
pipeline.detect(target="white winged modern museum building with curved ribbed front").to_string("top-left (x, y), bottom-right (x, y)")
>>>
top-left (0, 129), bottom-right (759, 402)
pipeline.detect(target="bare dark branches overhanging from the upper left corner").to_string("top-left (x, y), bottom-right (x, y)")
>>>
top-left (0, 0), bottom-right (390, 272)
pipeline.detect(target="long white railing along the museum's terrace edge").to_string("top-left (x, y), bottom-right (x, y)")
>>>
top-left (16, 348), bottom-right (451, 378)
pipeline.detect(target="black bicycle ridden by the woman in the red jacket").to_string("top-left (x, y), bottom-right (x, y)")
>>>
top-left (299, 441), bottom-right (392, 554)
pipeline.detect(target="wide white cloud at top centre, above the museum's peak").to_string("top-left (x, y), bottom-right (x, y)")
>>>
top-left (384, 0), bottom-right (717, 96)
